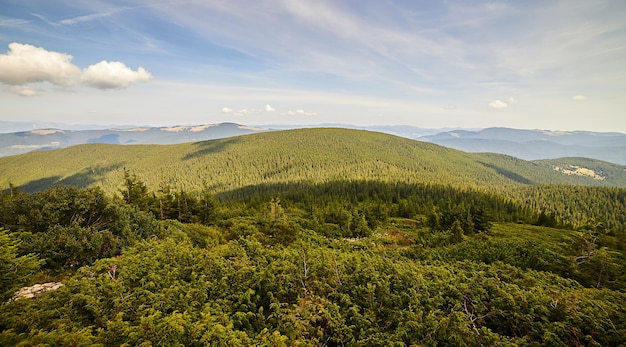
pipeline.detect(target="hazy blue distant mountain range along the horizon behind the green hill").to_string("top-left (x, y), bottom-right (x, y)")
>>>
top-left (0, 122), bottom-right (626, 165)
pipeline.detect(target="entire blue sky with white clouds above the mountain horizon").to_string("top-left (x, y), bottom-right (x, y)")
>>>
top-left (0, 0), bottom-right (626, 132)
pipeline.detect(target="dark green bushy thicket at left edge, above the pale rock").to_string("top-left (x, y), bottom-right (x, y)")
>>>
top-left (0, 186), bottom-right (160, 271)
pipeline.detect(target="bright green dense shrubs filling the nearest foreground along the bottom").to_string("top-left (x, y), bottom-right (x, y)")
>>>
top-left (0, 236), bottom-right (626, 346)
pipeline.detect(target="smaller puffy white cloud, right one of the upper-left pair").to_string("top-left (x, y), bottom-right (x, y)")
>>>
top-left (81, 60), bottom-right (152, 89)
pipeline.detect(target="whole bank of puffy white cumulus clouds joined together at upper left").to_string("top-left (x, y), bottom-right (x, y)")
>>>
top-left (0, 42), bottom-right (152, 96)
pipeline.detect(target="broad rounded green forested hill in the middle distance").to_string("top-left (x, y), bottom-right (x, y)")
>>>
top-left (0, 128), bottom-right (626, 193)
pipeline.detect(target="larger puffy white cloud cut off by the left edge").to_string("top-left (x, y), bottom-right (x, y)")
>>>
top-left (0, 42), bottom-right (81, 86)
